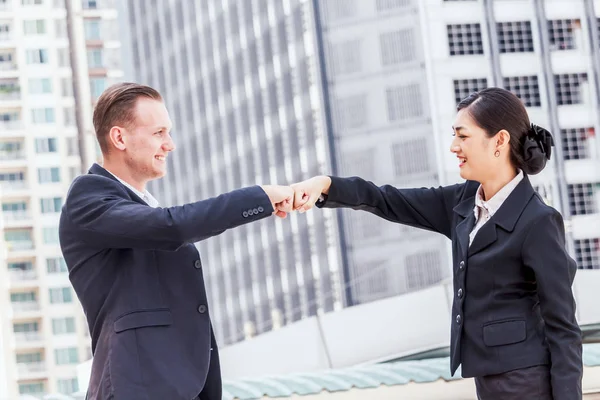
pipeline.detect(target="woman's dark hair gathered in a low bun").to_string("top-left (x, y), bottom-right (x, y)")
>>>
top-left (457, 87), bottom-right (554, 175)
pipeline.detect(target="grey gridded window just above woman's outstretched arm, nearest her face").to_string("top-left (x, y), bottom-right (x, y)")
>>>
top-left (392, 138), bottom-right (432, 178)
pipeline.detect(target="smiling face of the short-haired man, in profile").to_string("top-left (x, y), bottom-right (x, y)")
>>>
top-left (123, 97), bottom-right (175, 183)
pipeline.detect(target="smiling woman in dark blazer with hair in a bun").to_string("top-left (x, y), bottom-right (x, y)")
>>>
top-left (292, 88), bottom-right (583, 400)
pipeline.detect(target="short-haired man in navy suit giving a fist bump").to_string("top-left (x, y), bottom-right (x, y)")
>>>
top-left (59, 83), bottom-right (294, 400)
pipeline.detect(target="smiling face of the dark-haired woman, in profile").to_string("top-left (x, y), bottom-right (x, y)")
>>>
top-left (450, 108), bottom-right (507, 182)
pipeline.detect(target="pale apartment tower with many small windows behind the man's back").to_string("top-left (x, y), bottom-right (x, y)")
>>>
top-left (0, 0), bottom-right (122, 399)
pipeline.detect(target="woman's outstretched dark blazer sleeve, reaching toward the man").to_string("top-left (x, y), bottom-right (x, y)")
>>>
top-left (317, 176), bottom-right (465, 238)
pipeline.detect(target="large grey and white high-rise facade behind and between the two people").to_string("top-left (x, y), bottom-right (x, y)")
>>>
top-left (123, 0), bottom-right (600, 344)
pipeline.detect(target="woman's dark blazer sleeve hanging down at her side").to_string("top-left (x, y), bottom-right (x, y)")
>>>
top-left (523, 210), bottom-right (583, 400)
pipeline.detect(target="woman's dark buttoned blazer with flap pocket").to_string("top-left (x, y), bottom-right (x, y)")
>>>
top-left (317, 176), bottom-right (583, 400)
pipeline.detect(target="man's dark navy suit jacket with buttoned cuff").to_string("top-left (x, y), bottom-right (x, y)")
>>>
top-left (59, 164), bottom-right (273, 400)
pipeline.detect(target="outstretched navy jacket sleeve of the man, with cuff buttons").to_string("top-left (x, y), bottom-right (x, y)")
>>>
top-left (59, 174), bottom-right (273, 251)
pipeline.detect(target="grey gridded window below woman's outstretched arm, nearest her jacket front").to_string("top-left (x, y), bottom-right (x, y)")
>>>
top-left (404, 251), bottom-right (444, 290)
